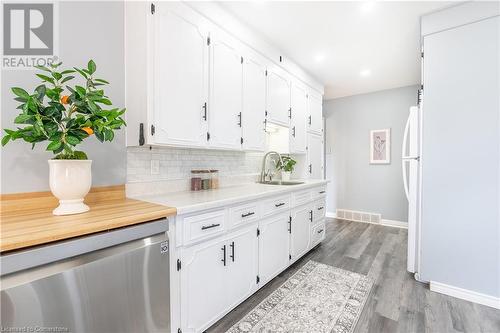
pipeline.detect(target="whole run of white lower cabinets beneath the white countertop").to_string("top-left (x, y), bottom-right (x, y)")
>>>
top-left (178, 184), bottom-right (325, 333)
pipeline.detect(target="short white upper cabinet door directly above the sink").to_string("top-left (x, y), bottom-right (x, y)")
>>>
top-left (266, 68), bottom-right (290, 126)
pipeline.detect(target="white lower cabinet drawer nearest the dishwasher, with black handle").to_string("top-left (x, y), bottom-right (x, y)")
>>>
top-left (182, 209), bottom-right (226, 243)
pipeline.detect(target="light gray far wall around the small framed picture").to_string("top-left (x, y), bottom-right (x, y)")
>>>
top-left (323, 86), bottom-right (418, 222)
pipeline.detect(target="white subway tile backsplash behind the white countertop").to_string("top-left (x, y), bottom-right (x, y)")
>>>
top-left (127, 146), bottom-right (263, 196)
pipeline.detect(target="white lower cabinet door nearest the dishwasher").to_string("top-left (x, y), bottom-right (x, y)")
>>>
top-left (180, 238), bottom-right (229, 332)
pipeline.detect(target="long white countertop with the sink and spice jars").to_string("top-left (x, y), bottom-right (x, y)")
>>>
top-left (132, 180), bottom-right (328, 215)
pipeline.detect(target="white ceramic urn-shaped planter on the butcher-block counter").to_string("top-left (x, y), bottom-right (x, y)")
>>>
top-left (49, 160), bottom-right (92, 215)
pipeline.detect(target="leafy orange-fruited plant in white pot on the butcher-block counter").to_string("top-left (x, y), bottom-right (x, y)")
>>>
top-left (2, 60), bottom-right (125, 215)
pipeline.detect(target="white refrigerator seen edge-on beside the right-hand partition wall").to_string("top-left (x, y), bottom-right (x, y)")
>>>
top-left (401, 106), bottom-right (421, 280)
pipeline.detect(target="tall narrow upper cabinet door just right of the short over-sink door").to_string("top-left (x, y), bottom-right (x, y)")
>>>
top-left (290, 82), bottom-right (307, 154)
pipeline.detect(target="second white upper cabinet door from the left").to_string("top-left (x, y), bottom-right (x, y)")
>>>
top-left (208, 32), bottom-right (243, 149)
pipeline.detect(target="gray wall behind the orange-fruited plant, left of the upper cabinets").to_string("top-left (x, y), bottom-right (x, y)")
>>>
top-left (1, 2), bottom-right (127, 193)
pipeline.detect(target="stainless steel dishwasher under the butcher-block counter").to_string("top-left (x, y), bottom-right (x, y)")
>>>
top-left (0, 220), bottom-right (170, 333)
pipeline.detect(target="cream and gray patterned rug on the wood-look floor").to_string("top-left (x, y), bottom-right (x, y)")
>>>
top-left (227, 261), bottom-right (373, 333)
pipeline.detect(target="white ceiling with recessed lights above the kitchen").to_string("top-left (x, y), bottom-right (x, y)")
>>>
top-left (220, 1), bottom-right (450, 99)
